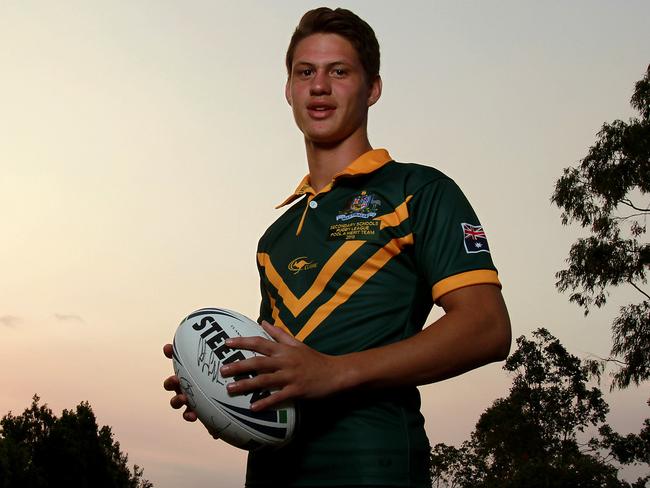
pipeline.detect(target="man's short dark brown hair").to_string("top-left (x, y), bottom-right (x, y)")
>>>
top-left (285, 7), bottom-right (379, 84)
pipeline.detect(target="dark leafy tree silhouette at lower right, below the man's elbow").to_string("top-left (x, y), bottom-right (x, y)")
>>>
top-left (431, 329), bottom-right (650, 488)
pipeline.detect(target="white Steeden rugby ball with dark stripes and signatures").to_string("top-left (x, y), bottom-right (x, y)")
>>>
top-left (172, 308), bottom-right (296, 451)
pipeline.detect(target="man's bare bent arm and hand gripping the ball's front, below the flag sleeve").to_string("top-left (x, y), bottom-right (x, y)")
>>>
top-left (221, 285), bottom-right (511, 410)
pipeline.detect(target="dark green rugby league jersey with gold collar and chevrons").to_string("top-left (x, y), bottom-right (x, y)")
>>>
top-left (246, 149), bottom-right (500, 487)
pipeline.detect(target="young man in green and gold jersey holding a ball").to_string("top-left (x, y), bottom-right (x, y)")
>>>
top-left (165, 8), bottom-right (510, 487)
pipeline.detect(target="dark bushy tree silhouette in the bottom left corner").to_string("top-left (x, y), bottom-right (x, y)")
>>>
top-left (0, 395), bottom-right (153, 488)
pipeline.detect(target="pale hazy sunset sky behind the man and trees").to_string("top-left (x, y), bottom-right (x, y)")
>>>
top-left (0, 0), bottom-right (650, 488)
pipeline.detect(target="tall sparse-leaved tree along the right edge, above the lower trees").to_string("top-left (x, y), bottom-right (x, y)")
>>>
top-left (551, 66), bottom-right (650, 388)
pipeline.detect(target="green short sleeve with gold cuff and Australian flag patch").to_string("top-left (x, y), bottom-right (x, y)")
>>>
top-left (409, 177), bottom-right (501, 301)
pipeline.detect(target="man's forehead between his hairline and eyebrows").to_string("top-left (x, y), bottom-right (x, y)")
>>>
top-left (293, 33), bottom-right (360, 65)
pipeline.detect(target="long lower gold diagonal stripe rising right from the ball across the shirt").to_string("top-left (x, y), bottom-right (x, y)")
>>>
top-left (296, 234), bottom-right (413, 341)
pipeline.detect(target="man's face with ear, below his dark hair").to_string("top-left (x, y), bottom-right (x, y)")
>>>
top-left (286, 34), bottom-right (381, 145)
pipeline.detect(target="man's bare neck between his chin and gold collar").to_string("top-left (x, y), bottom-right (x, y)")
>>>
top-left (305, 127), bottom-right (372, 193)
